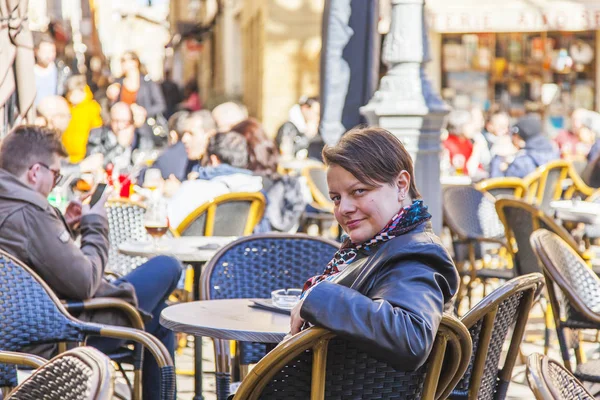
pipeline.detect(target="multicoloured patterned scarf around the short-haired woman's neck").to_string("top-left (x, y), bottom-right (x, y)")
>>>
top-left (302, 200), bottom-right (431, 297)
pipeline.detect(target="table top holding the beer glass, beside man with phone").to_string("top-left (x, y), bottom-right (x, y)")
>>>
top-left (119, 236), bottom-right (237, 262)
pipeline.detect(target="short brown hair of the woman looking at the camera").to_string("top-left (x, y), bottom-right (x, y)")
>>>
top-left (323, 127), bottom-right (421, 200)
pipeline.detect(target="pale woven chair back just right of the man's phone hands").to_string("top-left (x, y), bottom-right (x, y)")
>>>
top-left (106, 199), bottom-right (150, 276)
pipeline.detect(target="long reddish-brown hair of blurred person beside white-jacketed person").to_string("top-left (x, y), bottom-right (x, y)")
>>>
top-left (231, 118), bottom-right (279, 176)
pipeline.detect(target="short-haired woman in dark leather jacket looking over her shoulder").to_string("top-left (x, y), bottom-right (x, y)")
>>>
top-left (291, 128), bottom-right (459, 370)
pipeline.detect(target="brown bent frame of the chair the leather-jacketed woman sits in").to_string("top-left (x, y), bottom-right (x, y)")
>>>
top-left (234, 315), bottom-right (473, 400)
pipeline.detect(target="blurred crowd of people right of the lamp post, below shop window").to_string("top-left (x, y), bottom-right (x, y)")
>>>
top-left (442, 107), bottom-right (600, 181)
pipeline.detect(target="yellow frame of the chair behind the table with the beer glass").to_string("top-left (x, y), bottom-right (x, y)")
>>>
top-left (176, 192), bottom-right (266, 236)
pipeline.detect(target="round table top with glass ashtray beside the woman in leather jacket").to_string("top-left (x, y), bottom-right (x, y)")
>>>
top-left (160, 299), bottom-right (290, 343)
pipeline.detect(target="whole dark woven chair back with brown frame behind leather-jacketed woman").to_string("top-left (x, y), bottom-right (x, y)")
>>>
top-left (235, 316), bottom-right (471, 400)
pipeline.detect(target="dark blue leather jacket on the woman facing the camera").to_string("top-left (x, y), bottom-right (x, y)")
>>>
top-left (300, 223), bottom-right (459, 371)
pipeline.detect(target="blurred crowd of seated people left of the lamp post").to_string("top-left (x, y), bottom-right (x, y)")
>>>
top-left (29, 35), bottom-right (323, 232)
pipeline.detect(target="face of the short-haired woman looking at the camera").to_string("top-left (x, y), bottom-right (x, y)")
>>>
top-left (327, 164), bottom-right (411, 244)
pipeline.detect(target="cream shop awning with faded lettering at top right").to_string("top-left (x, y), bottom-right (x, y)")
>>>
top-left (426, 0), bottom-right (600, 33)
